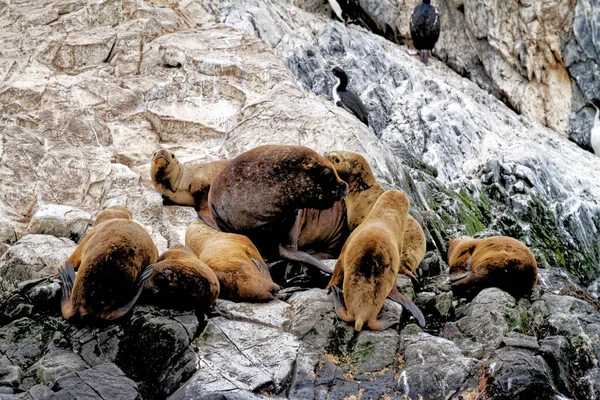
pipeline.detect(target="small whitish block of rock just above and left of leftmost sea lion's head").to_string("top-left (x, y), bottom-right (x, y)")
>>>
top-left (25, 204), bottom-right (92, 243)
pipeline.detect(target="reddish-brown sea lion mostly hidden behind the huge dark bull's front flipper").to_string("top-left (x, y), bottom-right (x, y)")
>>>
top-left (298, 200), bottom-right (350, 260)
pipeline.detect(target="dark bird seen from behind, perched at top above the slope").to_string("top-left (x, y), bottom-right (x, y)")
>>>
top-left (410, 0), bottom-right (440, 64)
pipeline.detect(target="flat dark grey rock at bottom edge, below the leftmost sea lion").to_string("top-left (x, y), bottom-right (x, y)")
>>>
top-left (50, 363), bottom-right (142, 400)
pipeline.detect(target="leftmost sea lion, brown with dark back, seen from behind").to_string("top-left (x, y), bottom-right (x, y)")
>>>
top-left (58, 209), bottom-right (158, 320)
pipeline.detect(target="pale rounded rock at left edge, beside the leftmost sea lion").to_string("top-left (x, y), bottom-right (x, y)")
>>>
top-left (0, 235), bottom-right (76, 290)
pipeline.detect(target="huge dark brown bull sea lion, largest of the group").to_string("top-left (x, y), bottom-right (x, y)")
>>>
top-left (208, 145), bottom-right (348, 273)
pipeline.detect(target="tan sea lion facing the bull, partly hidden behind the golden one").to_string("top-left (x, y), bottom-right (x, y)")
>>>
top-left (325, 150), bottom-right (427, 279)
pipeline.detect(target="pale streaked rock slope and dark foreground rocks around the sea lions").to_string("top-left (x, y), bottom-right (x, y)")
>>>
top-left (0, 0), bottom-right (600, 399)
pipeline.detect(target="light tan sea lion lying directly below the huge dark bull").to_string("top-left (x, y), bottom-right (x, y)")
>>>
top-left (185, 221), bottom-right (280, 301)
